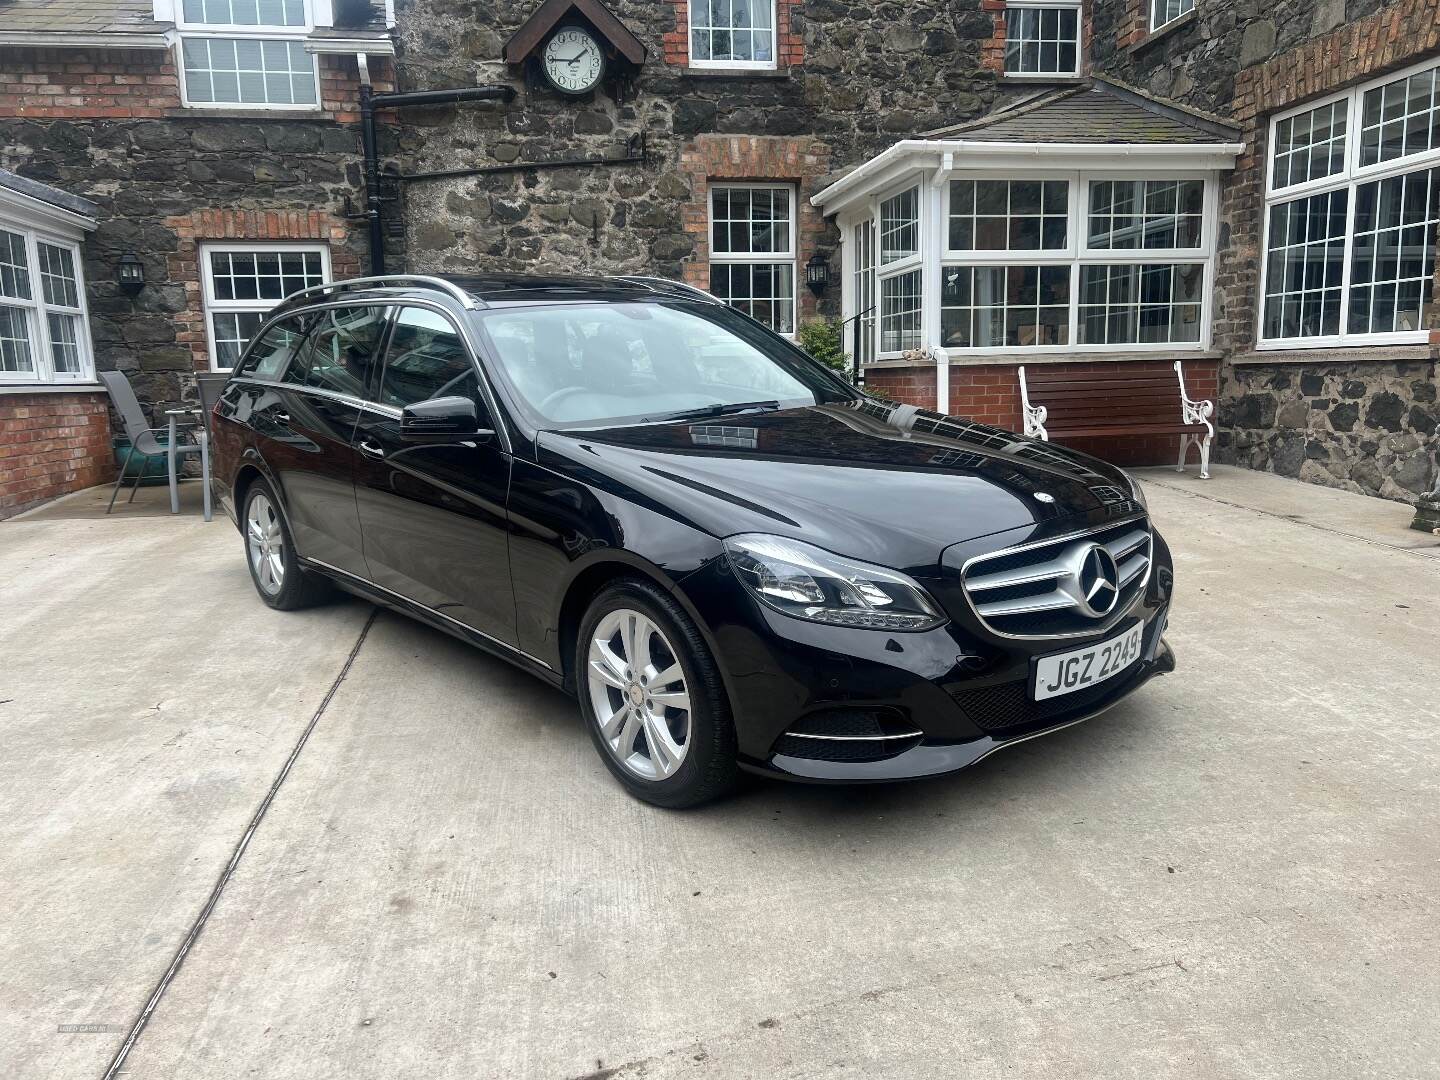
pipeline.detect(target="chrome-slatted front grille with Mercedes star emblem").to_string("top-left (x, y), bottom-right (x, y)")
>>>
top-left (960, 517), bottom-right (1155, 638)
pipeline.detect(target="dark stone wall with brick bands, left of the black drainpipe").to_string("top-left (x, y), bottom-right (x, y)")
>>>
top-left (0, 49), bottom-right (393, 416)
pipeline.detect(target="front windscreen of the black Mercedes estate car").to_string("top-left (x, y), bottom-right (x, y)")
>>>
top-left (478, 301), bottom-right (855, 428)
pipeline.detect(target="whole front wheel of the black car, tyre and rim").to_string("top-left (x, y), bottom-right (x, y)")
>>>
top-left (575, 579), bottom-right (739, 808)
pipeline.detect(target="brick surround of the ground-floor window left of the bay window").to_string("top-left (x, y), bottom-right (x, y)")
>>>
top-left (680, 135), bottom-right (840, 321)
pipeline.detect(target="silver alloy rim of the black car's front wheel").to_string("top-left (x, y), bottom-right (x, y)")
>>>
top-left (586, 608), bottom-right (691, 780)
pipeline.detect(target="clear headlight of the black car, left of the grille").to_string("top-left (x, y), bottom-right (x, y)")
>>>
top-left (724, 533), bottom-right (946, 631)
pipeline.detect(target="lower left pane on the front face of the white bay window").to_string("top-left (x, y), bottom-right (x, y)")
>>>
top-left (940, 266), bottom-right (1070, 348)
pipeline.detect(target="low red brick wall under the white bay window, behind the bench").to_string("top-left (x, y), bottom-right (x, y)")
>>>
top-left (865, 360), bottom-right (1220, 465)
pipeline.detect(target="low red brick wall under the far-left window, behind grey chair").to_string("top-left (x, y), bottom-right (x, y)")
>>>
top-left (0, 392), bottom-right (115, 518)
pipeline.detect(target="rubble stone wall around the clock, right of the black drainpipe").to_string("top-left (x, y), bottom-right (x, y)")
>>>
top-left (397, 0), bottom-right (998, 312)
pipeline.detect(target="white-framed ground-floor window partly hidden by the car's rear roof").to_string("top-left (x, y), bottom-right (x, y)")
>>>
top-left (200, 243), bottom-right (330, 372)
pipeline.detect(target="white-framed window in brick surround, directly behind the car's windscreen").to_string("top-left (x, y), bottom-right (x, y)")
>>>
top-left (710, 184), bottom-right (796, 334)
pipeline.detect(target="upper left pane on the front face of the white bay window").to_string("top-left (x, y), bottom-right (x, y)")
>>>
top-left (950, 178), bottom-right (1070, 251)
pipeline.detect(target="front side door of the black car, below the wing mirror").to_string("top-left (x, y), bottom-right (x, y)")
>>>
top-left (354, 305), bottom-right (516, 645)
